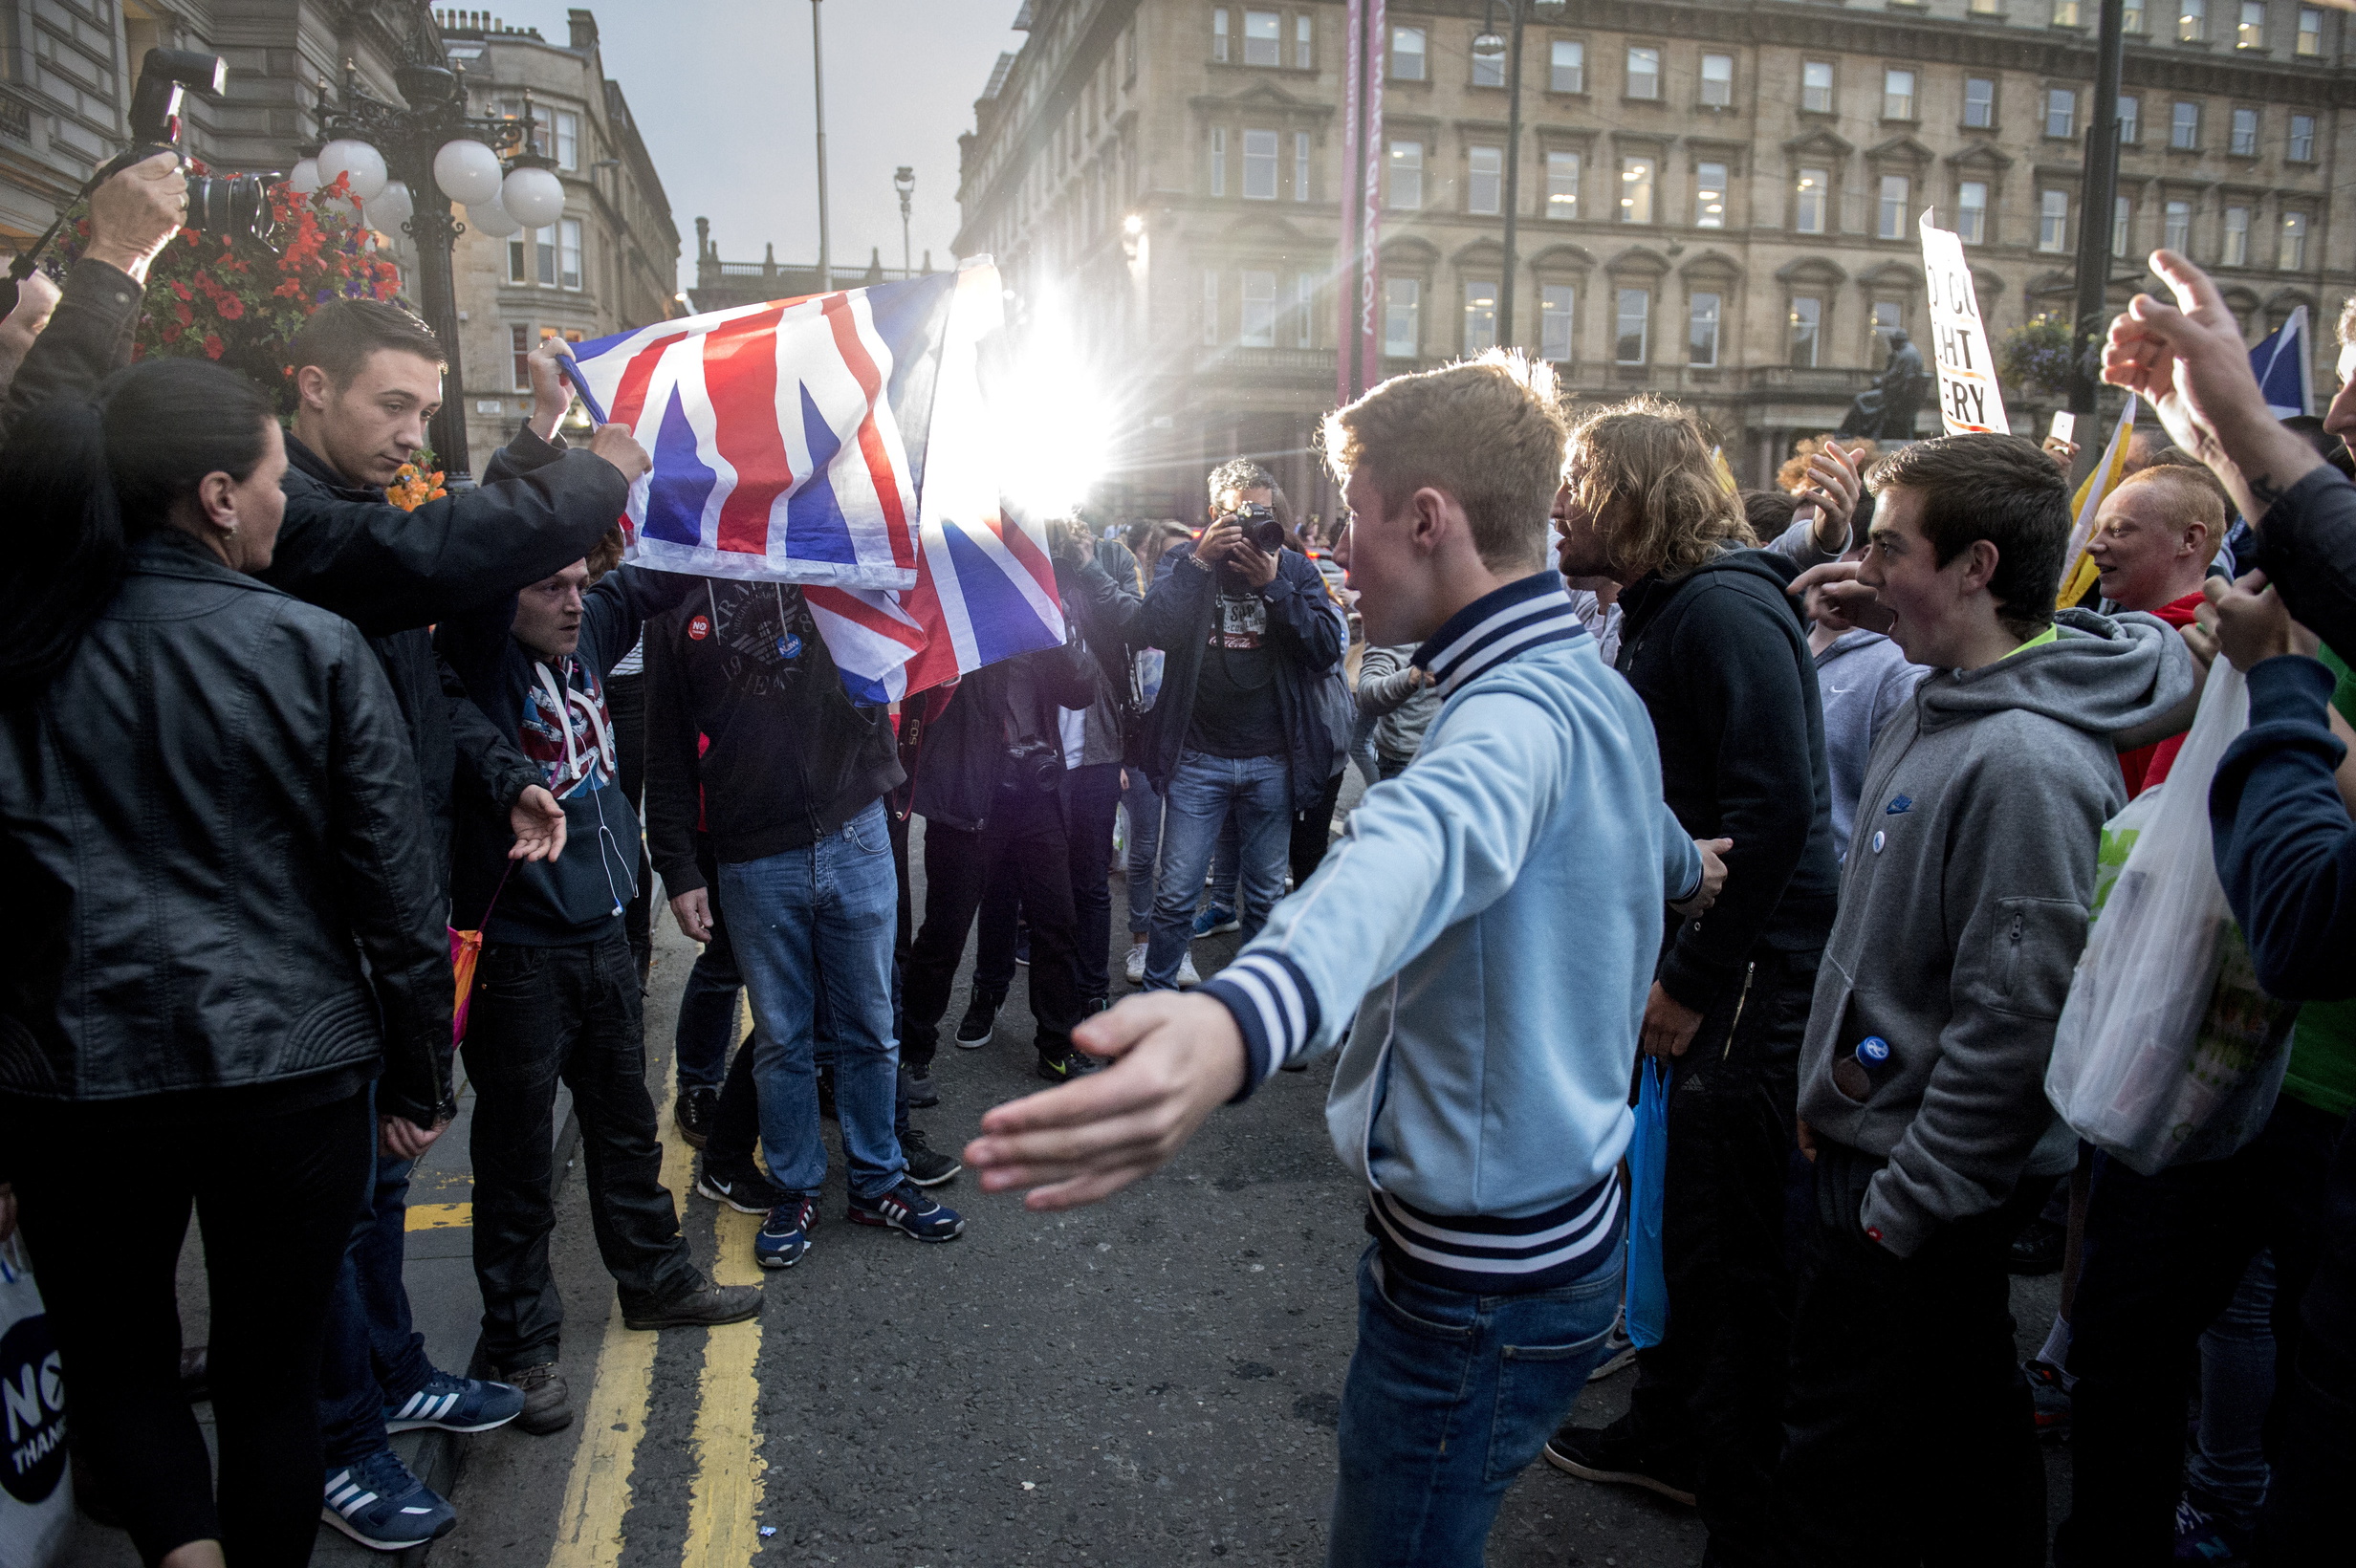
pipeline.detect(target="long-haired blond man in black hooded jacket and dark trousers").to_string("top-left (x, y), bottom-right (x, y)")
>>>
top-left (1548, 401), bottom-right (1838, 1563)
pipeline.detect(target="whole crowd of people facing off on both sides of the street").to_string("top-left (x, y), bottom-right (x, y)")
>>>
top-left (0, 149), bottom-right (2356, 1568)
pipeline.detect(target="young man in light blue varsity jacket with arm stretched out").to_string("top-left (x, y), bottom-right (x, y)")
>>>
top-left (966, 353), bottom-right (1722, 1568)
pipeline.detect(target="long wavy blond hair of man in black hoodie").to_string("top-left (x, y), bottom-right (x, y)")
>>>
top-left (1564, 398), bottom-right (1757, 577)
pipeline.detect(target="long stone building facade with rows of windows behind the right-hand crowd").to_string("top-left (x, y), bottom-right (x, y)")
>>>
top-left (959, 0), bottom-right (2356, 513)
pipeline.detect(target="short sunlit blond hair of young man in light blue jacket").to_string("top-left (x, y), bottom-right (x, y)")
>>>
top-left (1321, 348), bottom-right (1569, 570)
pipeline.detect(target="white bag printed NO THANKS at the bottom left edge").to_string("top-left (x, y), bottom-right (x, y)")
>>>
top-left (0, 1238), bottom-right (73, 1568)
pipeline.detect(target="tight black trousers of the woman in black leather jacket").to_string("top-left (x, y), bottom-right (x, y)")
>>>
top-left (0, 1093), bottom-right (377, 1568)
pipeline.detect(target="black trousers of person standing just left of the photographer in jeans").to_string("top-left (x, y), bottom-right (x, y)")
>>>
top-left (900, 791), bottom-right (1081, 1069)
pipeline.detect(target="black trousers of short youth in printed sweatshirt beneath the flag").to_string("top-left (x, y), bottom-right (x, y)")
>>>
top-left (467, 930), bottom-right (700, 1368)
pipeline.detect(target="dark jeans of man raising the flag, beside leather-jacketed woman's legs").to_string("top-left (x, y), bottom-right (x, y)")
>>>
top-left (318, 1087), bottom-right (433, 1470)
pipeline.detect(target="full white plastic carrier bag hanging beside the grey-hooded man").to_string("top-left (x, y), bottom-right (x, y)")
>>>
top-left (2045, 659), bottom-right (2292, 1175)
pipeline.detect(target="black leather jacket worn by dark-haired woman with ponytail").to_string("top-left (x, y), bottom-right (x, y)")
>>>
top-left (0, 533), bottom-right (452, 1125)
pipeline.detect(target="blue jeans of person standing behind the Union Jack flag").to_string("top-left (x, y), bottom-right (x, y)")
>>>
top-left (721, 803), bottom-right (907, 1198)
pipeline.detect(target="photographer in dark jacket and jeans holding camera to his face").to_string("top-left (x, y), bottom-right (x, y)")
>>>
top-left (1128, 457), bottom-right (1345, 991)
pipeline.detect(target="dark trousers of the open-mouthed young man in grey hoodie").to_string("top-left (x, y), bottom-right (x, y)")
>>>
top-left (1771, 1137), bottom-right (2054, 1568)
